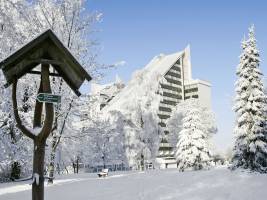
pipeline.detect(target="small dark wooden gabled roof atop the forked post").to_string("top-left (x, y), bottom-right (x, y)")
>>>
top-left (0, 29), bottom-right (92, 96)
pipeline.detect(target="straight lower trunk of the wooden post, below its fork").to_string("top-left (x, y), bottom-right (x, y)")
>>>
top-left (32, 140), bottom-right (45, 200)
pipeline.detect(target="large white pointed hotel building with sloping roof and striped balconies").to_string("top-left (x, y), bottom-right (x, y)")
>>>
top-left (99, 46), bottom-right (211, 168)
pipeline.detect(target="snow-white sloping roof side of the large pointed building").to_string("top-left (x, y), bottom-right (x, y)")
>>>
top-left (103, 51), bottom-right (184, 112)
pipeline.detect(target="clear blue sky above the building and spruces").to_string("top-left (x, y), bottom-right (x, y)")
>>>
top-left (87, 0), bottom-right (267, 152)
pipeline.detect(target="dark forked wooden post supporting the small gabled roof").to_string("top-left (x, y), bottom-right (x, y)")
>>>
top-left (12, 64), bottom-right (54, 200)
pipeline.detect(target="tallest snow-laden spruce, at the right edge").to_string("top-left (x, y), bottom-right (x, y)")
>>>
top-left (233, 26), bottom-right (267, 172)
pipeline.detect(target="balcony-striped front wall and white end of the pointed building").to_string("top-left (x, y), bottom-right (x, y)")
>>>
top-left (158, 47), bottom-right (211, 163)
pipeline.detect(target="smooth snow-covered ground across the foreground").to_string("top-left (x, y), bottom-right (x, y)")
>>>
top-left (0, 168), bottom-right (267, 200)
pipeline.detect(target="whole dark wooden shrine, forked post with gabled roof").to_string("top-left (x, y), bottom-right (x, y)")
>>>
top-left (0, 30), bottom-right (92, 200)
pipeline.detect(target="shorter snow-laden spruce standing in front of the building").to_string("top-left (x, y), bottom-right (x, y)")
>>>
top-left (175, 107), bottom-right (214, 171)
